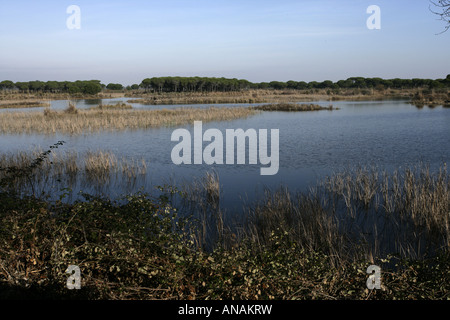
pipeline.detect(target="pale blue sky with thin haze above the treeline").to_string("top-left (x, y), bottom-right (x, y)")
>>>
top-left (0, 0), bottom-right (450, 85)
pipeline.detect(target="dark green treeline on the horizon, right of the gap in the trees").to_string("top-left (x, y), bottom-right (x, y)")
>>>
top-left (140, 75), bottom-right (450, 92)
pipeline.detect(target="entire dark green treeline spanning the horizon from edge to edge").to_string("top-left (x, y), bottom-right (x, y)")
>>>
top-left (0, 75), bottom-right (450, 94)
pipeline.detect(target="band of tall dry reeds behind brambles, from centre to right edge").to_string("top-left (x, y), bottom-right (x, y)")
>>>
top-left (153, 164), bottom-right (450, 266)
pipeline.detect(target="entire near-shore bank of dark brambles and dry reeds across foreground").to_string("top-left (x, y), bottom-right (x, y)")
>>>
top-left (0, 148), bottom-right (450, 300)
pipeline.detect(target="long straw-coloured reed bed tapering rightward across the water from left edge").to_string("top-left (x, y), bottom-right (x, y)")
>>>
top-left (0, 107), bottom-right (257, 134)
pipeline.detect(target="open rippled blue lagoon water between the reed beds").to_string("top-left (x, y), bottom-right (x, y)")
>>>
top-left (0, 98), bottom-right (450, 210)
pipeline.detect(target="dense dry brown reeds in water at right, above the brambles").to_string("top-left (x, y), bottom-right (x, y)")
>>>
top-left (245, 164), bottom-right (450, 263)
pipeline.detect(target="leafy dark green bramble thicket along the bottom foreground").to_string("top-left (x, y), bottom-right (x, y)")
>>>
top-left (0, 194), bottom-right (450, 300)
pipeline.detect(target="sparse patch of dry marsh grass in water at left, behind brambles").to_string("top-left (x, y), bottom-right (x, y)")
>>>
top-left (0, 149), bottom-right (147, 195)
